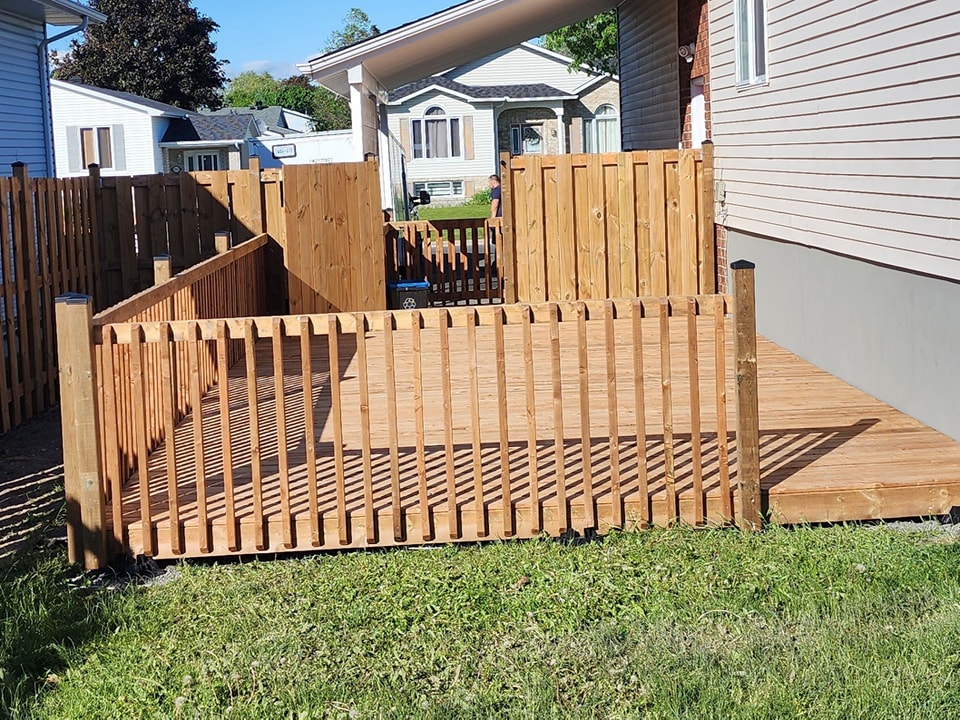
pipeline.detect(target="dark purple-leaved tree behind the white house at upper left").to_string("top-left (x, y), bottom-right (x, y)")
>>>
top-left (53, 0), bottom-right (226, 110)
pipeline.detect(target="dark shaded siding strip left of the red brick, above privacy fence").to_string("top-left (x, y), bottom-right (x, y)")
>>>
top-left (620, 0), bottom-right (680, 150)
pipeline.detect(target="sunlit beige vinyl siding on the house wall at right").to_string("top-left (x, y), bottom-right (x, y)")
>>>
top-left (710, 0), bottom-right (960, 280)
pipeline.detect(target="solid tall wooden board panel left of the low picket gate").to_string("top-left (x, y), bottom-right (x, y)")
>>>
top-left (283, 161), bottom-right (387, 314)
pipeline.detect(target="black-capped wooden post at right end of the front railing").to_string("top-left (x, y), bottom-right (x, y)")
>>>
top-left (730, 260), bottom-right (763, 531)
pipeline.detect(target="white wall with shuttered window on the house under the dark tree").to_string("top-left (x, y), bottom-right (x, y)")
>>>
top-left (50, 81), bottom-right (161, 177)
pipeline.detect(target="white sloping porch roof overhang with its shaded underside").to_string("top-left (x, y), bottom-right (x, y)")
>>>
top-left (298, 0), bottom-right (621, 97)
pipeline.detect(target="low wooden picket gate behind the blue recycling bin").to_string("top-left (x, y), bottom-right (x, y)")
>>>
top-left (384, 218), bottom-right (503, 305)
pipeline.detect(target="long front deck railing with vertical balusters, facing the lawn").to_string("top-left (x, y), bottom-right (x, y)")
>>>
top-left (62, 262), bottom-right (759, 567)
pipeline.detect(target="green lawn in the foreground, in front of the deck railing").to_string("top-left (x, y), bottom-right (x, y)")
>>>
top-left (0, 527), bottom-right (960, 720)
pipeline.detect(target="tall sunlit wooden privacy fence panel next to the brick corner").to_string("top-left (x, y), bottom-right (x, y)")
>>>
top-left (501, 144), bottom-right (716, 302)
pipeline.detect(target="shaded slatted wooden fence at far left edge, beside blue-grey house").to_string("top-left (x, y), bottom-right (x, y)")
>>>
top-left (0, 164), bottom-right (100, 433)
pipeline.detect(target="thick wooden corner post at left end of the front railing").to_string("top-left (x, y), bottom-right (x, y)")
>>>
top-left (56, 293), bottom-right (107, 570)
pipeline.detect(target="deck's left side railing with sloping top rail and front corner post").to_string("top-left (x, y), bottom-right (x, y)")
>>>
top-left (57, 235), bottom-right (270, 564)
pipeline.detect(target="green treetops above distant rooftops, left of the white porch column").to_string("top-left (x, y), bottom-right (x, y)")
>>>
top-left (223, 72), bottom-right (350, 131)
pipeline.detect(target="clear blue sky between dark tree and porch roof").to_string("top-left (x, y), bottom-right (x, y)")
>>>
top-left (193, 0), bottom-right (459, 77)
